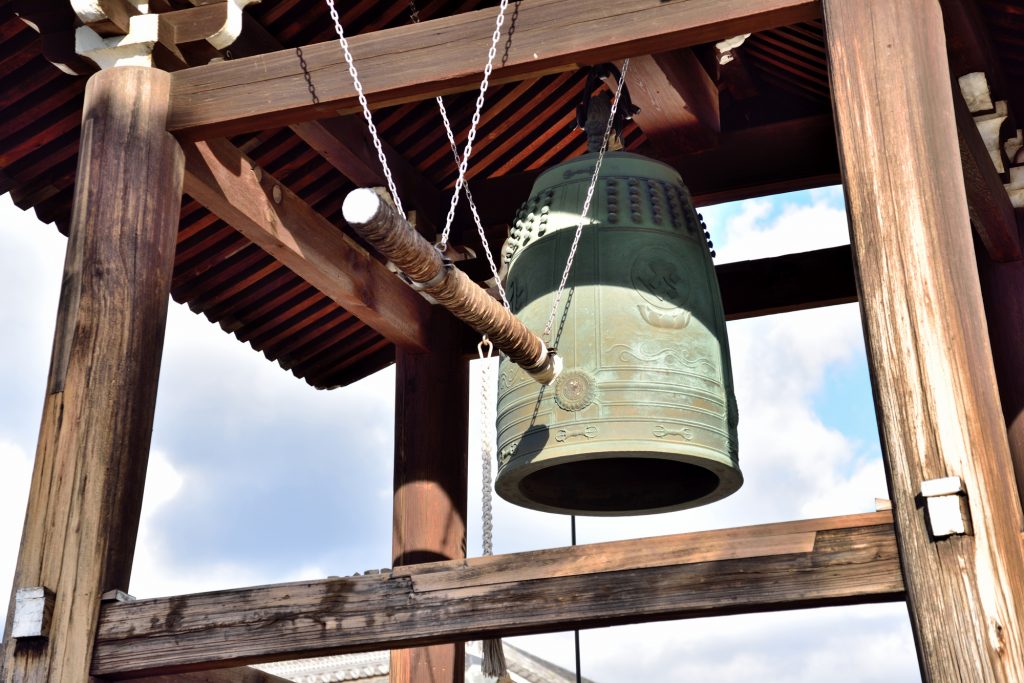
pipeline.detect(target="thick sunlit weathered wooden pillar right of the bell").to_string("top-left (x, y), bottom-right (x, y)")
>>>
top-left (823, 0), bottom-right (1024, 683)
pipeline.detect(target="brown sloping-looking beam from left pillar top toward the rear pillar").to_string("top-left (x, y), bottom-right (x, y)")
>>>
top-left (183, 139), bottom-right (430, 350)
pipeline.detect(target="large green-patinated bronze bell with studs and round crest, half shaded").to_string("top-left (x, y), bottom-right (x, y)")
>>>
top-left (495, 153), bottom-right (742, 516)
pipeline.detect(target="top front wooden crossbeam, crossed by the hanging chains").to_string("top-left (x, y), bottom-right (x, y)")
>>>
top-left (168, 0), bottom-right (820, 138)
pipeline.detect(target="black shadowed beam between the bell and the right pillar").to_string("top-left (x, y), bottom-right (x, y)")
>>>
top-left (715, 245), bottom-right (857, 321)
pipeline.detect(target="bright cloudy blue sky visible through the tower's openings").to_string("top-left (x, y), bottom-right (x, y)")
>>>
top-left (0, 188), bottom-right (920, 683)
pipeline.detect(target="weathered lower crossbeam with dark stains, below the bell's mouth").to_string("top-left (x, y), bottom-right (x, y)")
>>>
top-left (92, 512), bottom-right (903, 678)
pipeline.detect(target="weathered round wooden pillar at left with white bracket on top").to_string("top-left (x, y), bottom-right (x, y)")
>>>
top-left (3, 68), bottom-right (183, 683)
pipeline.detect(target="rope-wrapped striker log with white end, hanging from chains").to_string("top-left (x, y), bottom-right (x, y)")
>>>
top-left (342, 188), bottom-right (558, 384)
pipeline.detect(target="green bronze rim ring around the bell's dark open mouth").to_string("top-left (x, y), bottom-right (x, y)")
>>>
top-left (495, 444), bottom-right (743, 517)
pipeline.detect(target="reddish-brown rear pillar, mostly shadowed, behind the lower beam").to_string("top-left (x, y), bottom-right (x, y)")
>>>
top-left (391, 310), bottom-right (469, 683)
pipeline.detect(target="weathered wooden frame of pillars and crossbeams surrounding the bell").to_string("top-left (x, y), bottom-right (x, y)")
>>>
top-left (0, 0), bottom-right (1024, 683)
